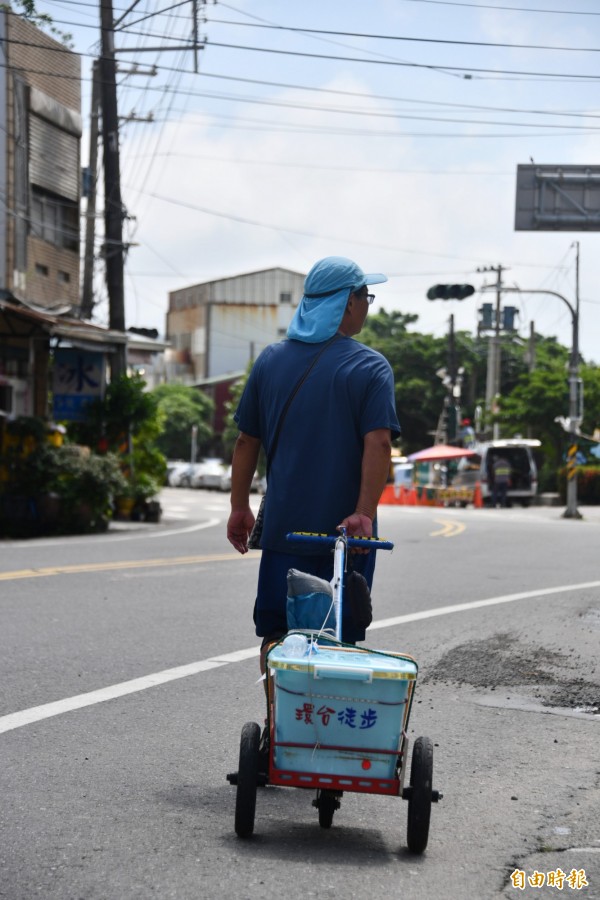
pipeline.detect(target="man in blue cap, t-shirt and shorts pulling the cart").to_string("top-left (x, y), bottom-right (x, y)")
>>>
top-left (227, 256), bottom-right (400, 671)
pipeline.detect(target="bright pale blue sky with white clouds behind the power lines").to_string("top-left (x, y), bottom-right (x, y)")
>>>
top-left (39, 0), bottom-right (600, 362)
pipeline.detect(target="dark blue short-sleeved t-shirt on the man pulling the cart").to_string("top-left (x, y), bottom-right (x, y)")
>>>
top-left (234, 337), bottom-right (400, 554)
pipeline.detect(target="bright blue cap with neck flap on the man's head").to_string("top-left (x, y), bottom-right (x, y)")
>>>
top-left (287, 256), bottom-right (387, 344)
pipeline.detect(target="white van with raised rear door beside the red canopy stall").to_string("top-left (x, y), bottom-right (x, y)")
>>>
top-left (452, 438), bottom-right (542, 506)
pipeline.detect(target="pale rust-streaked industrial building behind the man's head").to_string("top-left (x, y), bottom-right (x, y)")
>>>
top-left (166, 268), bottom-right (305, 384)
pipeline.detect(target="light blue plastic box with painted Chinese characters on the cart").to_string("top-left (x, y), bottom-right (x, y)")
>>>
top-left (267, 644), bottom-right (417, 790)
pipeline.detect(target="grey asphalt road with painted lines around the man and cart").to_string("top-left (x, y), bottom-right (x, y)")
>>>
top-left (0, 489), bottom-right (600, 900)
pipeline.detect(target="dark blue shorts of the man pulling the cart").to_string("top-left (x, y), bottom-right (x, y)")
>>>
top-left (254, 550), bottom-right (376, 643)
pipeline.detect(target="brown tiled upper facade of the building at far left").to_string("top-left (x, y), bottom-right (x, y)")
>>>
top-left (0, 11), bottom-right (82, 309)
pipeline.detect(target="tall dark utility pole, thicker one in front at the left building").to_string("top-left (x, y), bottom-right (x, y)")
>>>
top-left (100, 0), bottom-right (127, 378)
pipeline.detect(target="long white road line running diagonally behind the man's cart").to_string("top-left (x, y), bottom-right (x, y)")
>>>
top-left (0, 581), bottom-right (600, 734)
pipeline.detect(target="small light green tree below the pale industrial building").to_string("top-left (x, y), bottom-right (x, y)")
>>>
top-left (150, 384), bottom-right (214, 459)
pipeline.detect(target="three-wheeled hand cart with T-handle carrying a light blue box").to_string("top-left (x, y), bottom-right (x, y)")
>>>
top-left (227, 531), bottom-right (442, 853)
